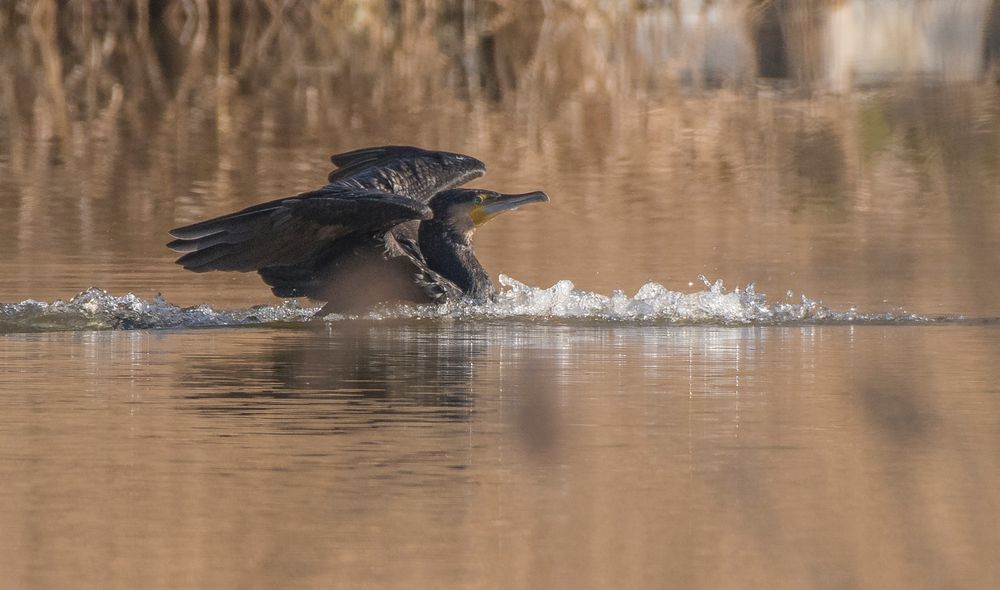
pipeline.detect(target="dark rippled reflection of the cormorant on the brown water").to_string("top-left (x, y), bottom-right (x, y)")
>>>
top-left (179, 322), bottom-right (488, 434)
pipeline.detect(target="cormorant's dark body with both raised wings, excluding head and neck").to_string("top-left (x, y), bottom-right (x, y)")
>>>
top-left (167, 146), bottom-right (486, 309)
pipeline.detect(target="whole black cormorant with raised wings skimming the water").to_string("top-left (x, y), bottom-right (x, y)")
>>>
top-left (167, 146), bottom-right (548, 314)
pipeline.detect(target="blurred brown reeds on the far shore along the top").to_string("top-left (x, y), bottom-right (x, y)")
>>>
top-left (7, 0), bottom-right (1000, 143)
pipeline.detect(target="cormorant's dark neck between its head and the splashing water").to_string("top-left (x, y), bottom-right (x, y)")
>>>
top-left (419, 219), bottom-right (496, 300)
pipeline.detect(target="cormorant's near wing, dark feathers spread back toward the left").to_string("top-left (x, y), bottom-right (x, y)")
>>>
top-left (167, 186), bottom-right (432, 272)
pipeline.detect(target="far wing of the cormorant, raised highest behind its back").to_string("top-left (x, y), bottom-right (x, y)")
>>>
top-left (328, 146), bottom-right (486, 203)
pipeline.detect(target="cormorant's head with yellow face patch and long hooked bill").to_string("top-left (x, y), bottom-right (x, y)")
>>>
top-left (428, 188), bottom-right (549, 236)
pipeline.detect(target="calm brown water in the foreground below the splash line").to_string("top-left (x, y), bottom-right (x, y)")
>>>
top-left (0, 322), bottom-right (1000, 588)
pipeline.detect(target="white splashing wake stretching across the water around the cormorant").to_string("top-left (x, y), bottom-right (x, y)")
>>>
top-left (0, 275), bottom-right (966, 333)
